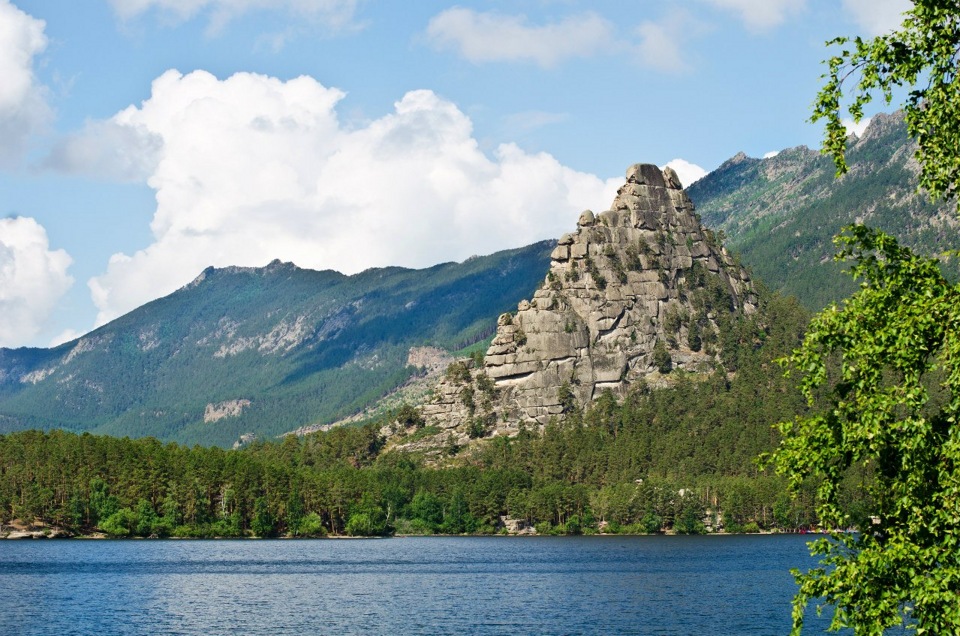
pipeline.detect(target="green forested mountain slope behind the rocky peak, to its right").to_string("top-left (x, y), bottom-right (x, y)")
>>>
top-left (687, 113), bottom-right (960, 309)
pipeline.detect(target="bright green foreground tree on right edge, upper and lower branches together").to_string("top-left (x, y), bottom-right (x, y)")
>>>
top-left (766, 0), bottom-right (960, 634)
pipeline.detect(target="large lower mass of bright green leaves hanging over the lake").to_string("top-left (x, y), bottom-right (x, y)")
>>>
top-left (768, 226), bottom-right (960, 634)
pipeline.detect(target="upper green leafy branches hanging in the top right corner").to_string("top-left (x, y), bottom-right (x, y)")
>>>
top-left (812, 0), bottom-right (960, 205)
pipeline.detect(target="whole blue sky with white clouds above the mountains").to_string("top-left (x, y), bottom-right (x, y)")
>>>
top-left (0, 0), bottom-right (910, 347)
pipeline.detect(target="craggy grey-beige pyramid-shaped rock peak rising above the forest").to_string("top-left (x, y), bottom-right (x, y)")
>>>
top-left (412, 164), bottom-right (756, 439)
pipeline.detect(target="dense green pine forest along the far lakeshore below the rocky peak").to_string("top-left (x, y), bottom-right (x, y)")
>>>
top-left (0, 297), bottom-right (862, 537)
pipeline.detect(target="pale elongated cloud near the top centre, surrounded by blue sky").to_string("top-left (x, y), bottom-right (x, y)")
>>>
top-left (427, 7), bottom-right (614, 67)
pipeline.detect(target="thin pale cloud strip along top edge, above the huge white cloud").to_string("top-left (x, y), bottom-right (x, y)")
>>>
top-left (110, 0), bottom-right (357, 32)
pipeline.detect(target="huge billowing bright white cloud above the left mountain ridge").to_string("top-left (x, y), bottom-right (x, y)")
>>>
top-left (74, 71), bottom-right (620, 323)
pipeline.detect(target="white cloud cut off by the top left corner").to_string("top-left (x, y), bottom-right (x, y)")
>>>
top-left (0, 0), bottom-right (51, 166)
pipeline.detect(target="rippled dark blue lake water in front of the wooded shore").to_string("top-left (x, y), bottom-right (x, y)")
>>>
top-left (0, 535), bottom-right (840, 636)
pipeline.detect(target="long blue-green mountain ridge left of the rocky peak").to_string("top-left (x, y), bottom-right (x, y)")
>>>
top-left (0, 241), bottom-right (555, 446)
